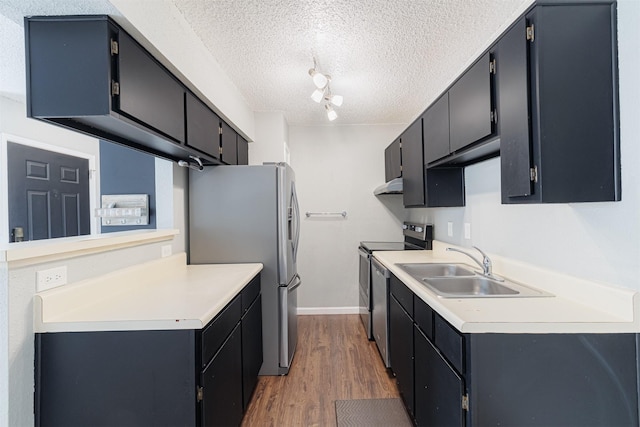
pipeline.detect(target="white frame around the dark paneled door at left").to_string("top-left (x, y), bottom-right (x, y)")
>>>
top-left (0, 133), bottom-right (100, 245)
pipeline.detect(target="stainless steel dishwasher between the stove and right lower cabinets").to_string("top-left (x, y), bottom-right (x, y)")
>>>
top-left (371, 257), bottom-right (391, 368)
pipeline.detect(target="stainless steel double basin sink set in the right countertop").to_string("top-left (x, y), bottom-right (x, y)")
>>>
top-left (397, 263), bottom-right (551, 298)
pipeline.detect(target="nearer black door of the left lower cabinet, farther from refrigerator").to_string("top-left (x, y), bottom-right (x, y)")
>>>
top-left (200, 325), bottom-right (243, 426)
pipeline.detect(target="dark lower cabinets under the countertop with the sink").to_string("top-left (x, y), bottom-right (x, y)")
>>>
top-left (389, 276), bottom-right (640, 427)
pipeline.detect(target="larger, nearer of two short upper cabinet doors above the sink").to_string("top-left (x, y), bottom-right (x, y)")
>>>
top-left (449, 53), bottom-right (493, 152)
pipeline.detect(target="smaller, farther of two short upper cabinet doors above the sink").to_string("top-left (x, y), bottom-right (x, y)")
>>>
top-left (422, 93), bottom-right (450, 165)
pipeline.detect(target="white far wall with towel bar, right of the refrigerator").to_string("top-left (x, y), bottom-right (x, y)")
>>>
top-left (289, 125), bottom-right (405, 313)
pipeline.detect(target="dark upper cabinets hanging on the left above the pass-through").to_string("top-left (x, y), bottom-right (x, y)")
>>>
top-left (25, 15), bottom-right (244, 165)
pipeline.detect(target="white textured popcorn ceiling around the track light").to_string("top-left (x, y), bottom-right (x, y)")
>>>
top-left (0, 0), bottom-right (532, 124)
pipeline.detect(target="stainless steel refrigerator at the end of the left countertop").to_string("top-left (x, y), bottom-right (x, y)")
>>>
top-left (189, 163), bottom-right (301, 375)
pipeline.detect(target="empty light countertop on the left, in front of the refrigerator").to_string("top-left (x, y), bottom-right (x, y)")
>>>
top-left (34, 253), bottom-right (262, 332)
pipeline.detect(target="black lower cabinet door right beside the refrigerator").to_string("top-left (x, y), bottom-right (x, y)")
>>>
top-left (242, 295), bottom-right (262, 411)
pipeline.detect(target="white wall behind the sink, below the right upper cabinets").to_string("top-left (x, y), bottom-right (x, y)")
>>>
top-left (409, 0), bottom-right (640, 290)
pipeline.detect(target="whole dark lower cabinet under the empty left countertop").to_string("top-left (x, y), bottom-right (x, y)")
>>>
top-left (34, 276), bottom-right (262, 427)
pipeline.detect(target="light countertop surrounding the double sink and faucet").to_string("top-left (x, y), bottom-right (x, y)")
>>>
top-left (374, 241), bottom-right (640, 333)
